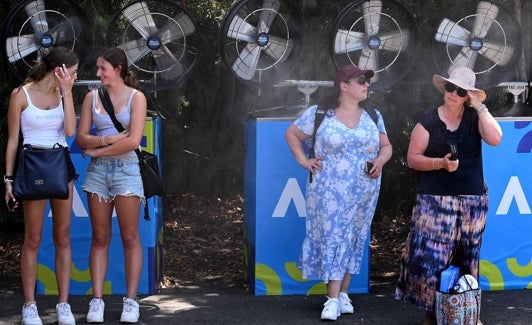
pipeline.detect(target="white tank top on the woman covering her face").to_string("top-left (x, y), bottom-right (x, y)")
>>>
top-left (20, 86), bottom-right (67, 148)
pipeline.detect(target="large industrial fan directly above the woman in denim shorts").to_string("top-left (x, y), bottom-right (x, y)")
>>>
top-left (106, 0), bottom-right (200, 90)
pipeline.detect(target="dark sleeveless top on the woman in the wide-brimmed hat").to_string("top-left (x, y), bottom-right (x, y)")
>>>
top-left (417, 107), bottom-right (485, 195)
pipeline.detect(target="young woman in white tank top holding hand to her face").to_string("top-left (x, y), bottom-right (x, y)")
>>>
top-left (4, 47), bottom-right (79, 325)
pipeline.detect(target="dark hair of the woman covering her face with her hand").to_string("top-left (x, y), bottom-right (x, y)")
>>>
top-left (24, 46), bottom-right (79, 84)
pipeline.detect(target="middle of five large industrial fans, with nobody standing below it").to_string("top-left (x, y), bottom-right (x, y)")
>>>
top-left (219, 0), bottom-right (304, 86)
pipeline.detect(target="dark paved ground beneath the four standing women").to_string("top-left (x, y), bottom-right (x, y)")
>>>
top-left (0, 277), bottom-right (532, 325)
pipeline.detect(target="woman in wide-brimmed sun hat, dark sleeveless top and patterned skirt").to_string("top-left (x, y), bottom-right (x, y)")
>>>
top-left (395, 67), bottom-right (502, 325)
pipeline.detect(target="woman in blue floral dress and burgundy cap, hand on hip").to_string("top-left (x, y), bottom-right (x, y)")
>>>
top-left (286, 65), bottom-right (392, 320)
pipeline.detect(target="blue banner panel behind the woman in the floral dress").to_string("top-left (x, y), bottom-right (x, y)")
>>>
top-left (244, 119), bottom-right (369, 295)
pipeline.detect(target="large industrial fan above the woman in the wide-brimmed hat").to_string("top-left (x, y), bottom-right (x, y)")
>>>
top-left (432, 1), bottom-right (521, 88)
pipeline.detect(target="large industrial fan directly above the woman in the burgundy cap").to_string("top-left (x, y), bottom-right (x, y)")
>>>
top-left (331, 0), bottom-right (417, 90)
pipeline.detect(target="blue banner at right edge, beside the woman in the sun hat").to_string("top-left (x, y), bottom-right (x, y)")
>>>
top-left (480, 119), bottom-right (532, 290)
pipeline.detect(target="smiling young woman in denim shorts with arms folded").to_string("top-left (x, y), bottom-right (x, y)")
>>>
top-left (76, 47), bottom-right (147, 323)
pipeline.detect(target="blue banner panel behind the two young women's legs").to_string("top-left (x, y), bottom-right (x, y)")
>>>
top-left (37, 118), bottom-right (163, 295)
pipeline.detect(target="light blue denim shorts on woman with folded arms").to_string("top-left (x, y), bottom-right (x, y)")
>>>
top-left (82, 157), bottom-right (144, 200)
